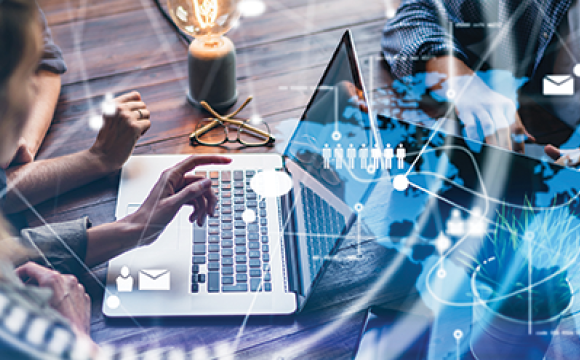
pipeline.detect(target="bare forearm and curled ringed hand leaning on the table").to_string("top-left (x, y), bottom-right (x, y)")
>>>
top-left (3, 92), bottom-right (151, 214)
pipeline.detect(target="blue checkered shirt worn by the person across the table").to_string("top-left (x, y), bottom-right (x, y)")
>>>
top-left (382, 0), bottom-right (572, 78)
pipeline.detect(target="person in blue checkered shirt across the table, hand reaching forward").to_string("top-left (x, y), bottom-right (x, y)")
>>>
top-left (382, 0), bottom-right (580, 165)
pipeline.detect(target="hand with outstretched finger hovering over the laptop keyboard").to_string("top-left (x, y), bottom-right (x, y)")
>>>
top-left (121, 155), bottom-right (231, 245)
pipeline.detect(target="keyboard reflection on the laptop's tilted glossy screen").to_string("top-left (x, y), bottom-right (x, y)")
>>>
top-left (300, 184), bottom-right (346, 281)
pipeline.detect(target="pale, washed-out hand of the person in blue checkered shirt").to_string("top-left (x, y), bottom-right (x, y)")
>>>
top-left (435, 75), bottom-right (534, 153)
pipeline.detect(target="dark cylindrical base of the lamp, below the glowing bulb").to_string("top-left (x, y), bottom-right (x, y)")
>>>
top-left (187, 36), bottom-right (238, 110)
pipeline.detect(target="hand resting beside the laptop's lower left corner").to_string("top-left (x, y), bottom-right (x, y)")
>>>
top-left (16, 262), bottom-right (91, 335)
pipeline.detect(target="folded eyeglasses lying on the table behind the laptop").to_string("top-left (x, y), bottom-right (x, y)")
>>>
top-left (189, 96), bottom-right (276, 147)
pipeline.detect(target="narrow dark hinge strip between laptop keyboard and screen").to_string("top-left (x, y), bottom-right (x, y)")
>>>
top-left (280, 190), bottom-right (301, 294)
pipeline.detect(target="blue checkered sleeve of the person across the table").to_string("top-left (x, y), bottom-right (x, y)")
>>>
top-left (382, 0), bottom-right (468, 78)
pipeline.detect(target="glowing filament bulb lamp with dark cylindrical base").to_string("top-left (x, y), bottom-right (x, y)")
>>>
top-left (167, 0), bottom-right (240, 109)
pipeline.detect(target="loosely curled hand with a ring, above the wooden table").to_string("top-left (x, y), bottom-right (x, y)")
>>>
top-left (90, 91), bottom-right (151, 171)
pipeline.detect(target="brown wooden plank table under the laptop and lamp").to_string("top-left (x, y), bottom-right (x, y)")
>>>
top-left (31, 0), bottom-right (410, 359)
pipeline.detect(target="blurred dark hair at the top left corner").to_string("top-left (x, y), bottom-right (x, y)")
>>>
top-left (0, 0), bottom-right (38, 91)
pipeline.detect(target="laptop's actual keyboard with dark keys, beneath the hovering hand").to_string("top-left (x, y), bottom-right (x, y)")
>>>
top-left (191, 170), bottom-right (272, 293)
